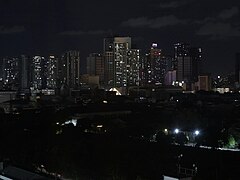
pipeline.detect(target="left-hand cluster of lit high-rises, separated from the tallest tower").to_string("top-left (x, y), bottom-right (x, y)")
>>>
top-left (0, 51), bottom-right (80, 94)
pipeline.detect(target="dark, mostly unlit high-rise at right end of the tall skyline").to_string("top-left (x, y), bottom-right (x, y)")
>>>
top-left (175, 43), bottom-right (202, 90)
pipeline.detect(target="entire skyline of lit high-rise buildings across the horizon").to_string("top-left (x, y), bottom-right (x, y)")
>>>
top-left (0, 37), bottom-right (214, 94)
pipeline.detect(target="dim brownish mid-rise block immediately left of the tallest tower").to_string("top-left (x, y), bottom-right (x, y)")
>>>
top-left (87, 53), bottom-right (105, 85)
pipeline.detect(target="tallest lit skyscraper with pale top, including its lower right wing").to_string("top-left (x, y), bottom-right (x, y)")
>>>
top-left (104, 37), bottom-right (140, 88)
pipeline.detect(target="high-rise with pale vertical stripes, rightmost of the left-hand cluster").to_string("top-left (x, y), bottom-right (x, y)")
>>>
top-left (58, 51), bottom-right (80, 89)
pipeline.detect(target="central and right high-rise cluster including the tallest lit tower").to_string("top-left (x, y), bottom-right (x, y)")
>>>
top-left (93, 37), bottom-right (202, 93)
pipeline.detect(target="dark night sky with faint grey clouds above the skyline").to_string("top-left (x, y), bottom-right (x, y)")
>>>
top-left (0, 0), bottom-right (240, 75)
